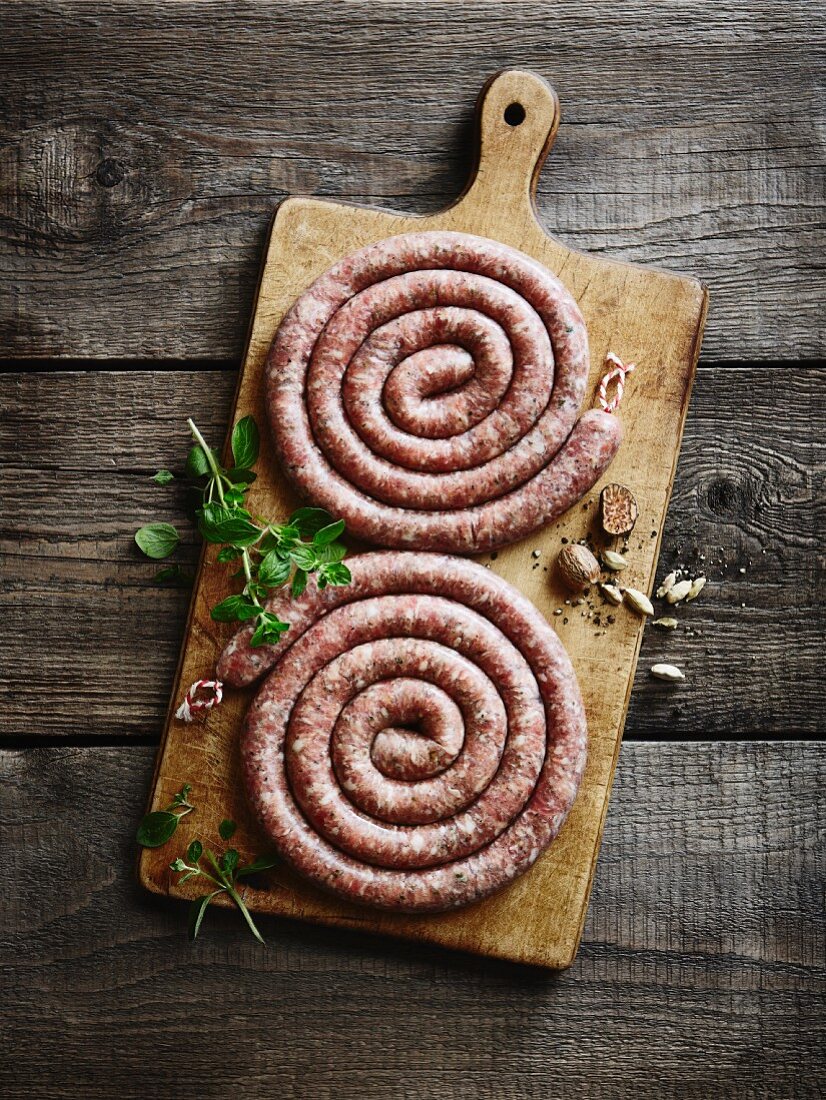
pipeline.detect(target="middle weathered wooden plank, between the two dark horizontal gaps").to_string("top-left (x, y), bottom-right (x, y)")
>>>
top-left (0, 366), bottom-right (826, 738)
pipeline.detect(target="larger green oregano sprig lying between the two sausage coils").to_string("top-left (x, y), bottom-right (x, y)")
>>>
top-left (135, 416), bottom-right (351, 646)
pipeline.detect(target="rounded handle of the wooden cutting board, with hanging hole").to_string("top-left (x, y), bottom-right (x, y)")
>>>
top-left (456, 69), bottom-right (560, 224)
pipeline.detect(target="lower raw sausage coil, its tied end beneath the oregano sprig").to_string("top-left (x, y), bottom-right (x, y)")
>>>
top-left (224, 551), bottom-right (586, 912)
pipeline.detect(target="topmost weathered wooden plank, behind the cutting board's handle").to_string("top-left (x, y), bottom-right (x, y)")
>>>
top-left (0, 0), bottom-right (824, 360)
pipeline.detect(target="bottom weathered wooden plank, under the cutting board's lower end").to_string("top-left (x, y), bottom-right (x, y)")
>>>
top-left (0, 744), bottom-right (826, 1100)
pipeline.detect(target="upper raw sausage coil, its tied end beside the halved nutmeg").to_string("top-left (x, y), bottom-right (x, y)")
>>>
top-left (267, 232), bottom-right (620, 552)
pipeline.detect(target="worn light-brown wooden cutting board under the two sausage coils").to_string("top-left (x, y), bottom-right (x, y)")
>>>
top-left (139, 70), bottom-right (707, 968)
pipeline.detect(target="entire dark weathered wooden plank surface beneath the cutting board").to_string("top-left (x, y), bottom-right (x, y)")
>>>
top-left (0, 0), bottom-right (826, 1100)
